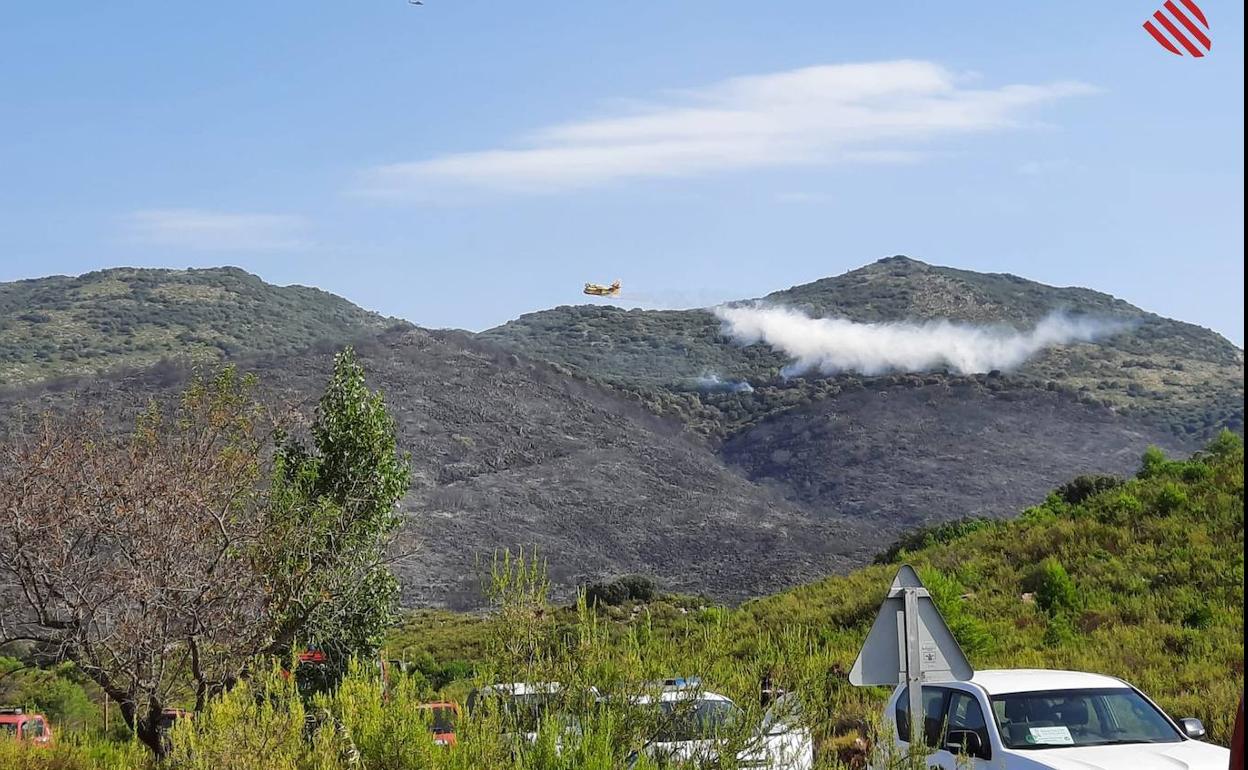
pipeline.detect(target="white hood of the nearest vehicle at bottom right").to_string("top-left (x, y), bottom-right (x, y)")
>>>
top-left (1017, 740), bottom-right (1231, 770)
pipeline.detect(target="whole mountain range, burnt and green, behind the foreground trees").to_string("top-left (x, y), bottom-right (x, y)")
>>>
top-left (0, 261), bottom-right (1243, 607)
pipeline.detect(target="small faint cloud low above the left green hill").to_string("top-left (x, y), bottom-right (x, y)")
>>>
top-left (124, 208), bottom-right (310, 251)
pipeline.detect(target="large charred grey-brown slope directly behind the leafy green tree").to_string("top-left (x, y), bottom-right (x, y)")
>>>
top-left (0, 329), bottom-right (886, 607)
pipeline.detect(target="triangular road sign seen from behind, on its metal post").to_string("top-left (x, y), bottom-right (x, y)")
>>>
top-left (850, 564), bottom-right (975, 745)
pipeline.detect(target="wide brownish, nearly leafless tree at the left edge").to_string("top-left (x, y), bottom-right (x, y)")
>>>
top-left (0, 353), bottom-right (406, 754)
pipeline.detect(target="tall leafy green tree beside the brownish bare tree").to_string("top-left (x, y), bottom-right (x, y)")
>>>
top-left (272, 348), bottom-right (409, 680)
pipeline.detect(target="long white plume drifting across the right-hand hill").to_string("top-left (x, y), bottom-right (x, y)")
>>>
top-left (714, 306), bottom-right (1128, 374)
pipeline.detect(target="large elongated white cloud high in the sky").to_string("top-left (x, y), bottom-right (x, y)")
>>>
top-left (361, 60), bottom-right (1093, 197)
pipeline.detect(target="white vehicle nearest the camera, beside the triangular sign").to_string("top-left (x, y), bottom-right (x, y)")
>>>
top-left (876, 669), bottom-right (1231, 770)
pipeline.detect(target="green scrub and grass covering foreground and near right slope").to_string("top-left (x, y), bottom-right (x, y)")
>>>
top-left (0, 433), bottom-right (1244, 770)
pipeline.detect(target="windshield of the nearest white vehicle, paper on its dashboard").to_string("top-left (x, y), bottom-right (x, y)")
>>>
top-left (992, 688), bottom-right (1183, 749)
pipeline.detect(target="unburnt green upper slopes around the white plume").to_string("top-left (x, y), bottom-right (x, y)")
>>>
top-left (482, 257), bottom-right (1243, 438)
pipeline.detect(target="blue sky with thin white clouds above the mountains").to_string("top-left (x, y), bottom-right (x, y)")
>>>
top-left (0, 0), bottom-right (1244, 346)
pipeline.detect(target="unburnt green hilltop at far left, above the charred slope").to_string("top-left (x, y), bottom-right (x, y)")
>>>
top-left (0, 267), bottom-right (393, 384)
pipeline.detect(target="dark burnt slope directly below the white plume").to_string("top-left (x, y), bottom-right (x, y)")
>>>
top-left (721, 377), bottom-right (1198, 535)
